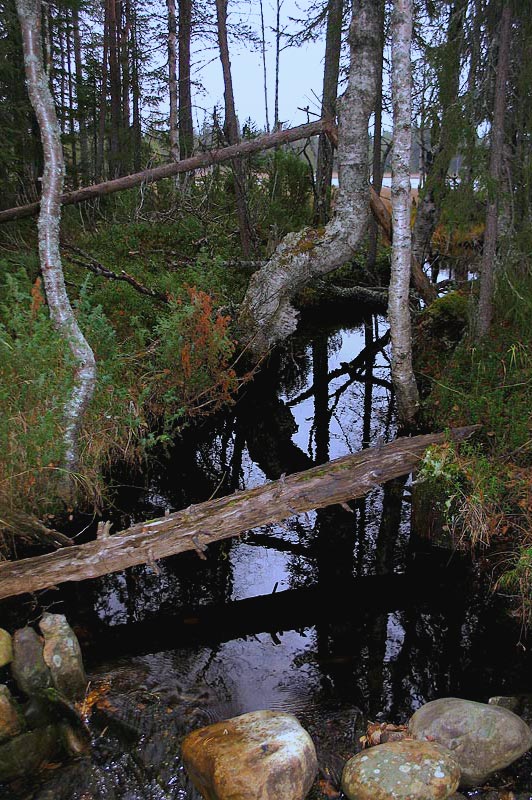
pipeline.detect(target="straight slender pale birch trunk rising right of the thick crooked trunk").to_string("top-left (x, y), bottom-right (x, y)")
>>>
top-left (388, 0), bottom-right (419, 428)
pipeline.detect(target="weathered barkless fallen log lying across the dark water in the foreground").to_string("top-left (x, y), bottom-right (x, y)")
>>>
top-left (0, 426), bottom-right (478, 599)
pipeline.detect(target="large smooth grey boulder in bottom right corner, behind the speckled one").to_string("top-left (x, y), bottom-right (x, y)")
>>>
top-left (409, 697), bottom-right (532, 787)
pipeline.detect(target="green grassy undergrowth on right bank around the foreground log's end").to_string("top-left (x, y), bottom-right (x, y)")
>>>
top-left (418, 269), bottom-right (532, 627)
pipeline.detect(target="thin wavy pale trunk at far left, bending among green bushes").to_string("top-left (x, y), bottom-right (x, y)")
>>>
top-left (16, 0), bottom-right (96, 474)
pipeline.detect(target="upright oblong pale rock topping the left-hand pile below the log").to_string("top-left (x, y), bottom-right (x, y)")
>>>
top-left (39, 614), bottom-right (87, 700)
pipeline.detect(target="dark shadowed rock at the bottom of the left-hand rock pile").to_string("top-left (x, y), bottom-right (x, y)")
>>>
top-left (0, 725), bottom-right (62, 783)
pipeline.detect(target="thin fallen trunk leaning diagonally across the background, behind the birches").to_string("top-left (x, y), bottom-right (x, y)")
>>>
top-left (0, 119), bottom-right (333, 223)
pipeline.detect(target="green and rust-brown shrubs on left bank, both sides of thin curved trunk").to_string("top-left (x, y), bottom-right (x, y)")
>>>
top-left (0, 262), bottom-right (237, 518)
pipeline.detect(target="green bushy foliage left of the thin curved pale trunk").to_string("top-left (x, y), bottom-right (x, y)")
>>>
top-left (0, 264), bottom-right (72, 511)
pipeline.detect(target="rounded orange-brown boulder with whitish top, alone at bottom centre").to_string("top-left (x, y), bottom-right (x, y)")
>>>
top-left (182, 711), bottom-right (318, 800)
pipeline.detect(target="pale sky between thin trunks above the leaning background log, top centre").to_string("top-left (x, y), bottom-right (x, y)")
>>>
top-left (187, 0), bottom-right (325, 134)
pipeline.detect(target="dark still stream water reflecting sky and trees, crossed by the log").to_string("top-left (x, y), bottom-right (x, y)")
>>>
top-left (0, 316), bottom-right (532, 800)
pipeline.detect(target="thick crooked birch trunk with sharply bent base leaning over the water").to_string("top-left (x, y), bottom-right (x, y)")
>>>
top-left (240, 0), bottom-right (380, 353)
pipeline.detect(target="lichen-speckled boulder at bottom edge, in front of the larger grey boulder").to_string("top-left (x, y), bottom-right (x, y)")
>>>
top-left (342, 740), bottom-right (460, 800)
